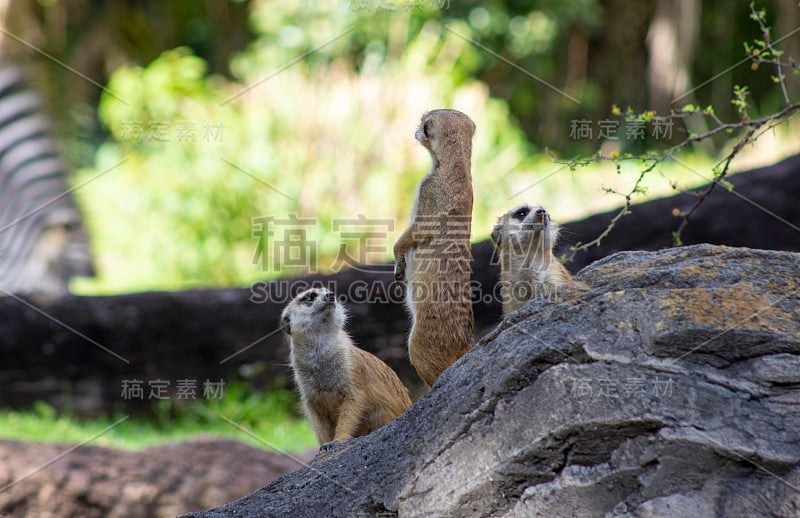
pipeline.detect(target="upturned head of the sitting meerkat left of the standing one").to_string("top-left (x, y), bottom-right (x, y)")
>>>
top-left (281, 288), bottom-right (347, 338)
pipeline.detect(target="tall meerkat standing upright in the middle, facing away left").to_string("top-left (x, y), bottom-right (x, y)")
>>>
top-left (394, 110), bottom-right (475, 386)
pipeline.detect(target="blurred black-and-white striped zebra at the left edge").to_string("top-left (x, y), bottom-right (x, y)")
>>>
top-left (0, 63), bottom-right (94, 299)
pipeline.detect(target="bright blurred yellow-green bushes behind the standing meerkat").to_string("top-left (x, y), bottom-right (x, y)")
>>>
top-left (77, 13), bottom-right (541, 292)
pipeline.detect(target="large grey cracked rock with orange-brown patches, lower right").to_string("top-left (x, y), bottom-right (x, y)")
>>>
top-left (187, 245), bottom-right (800, 518)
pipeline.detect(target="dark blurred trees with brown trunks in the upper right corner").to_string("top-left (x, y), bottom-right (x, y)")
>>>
top-left (445, 0), bottom-right (800, 155)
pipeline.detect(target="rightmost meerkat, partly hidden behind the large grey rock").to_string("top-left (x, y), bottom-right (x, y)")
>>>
top-left (492, 205), bottom-right (572, 317)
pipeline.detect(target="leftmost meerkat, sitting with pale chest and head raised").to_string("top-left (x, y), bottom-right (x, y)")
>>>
top-left (281, 288), bottom-right (411, 445)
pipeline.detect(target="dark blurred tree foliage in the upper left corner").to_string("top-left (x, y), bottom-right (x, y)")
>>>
top-left (0, 0), bottom-right (251, 165)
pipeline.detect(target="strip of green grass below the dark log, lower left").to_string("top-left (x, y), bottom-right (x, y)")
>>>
top-left (0, 384), bottom-right (316, 452)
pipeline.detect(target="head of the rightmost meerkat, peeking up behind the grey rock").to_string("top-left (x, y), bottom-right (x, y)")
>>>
top-left (492, 204), bottom-right (558, 266)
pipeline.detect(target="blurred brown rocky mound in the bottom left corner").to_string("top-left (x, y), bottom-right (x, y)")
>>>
top-left (0, 438), bottom-right (308, 518)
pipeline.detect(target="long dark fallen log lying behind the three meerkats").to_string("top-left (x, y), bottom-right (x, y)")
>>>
top-left (0, 155), bottom-right (800, 416)
